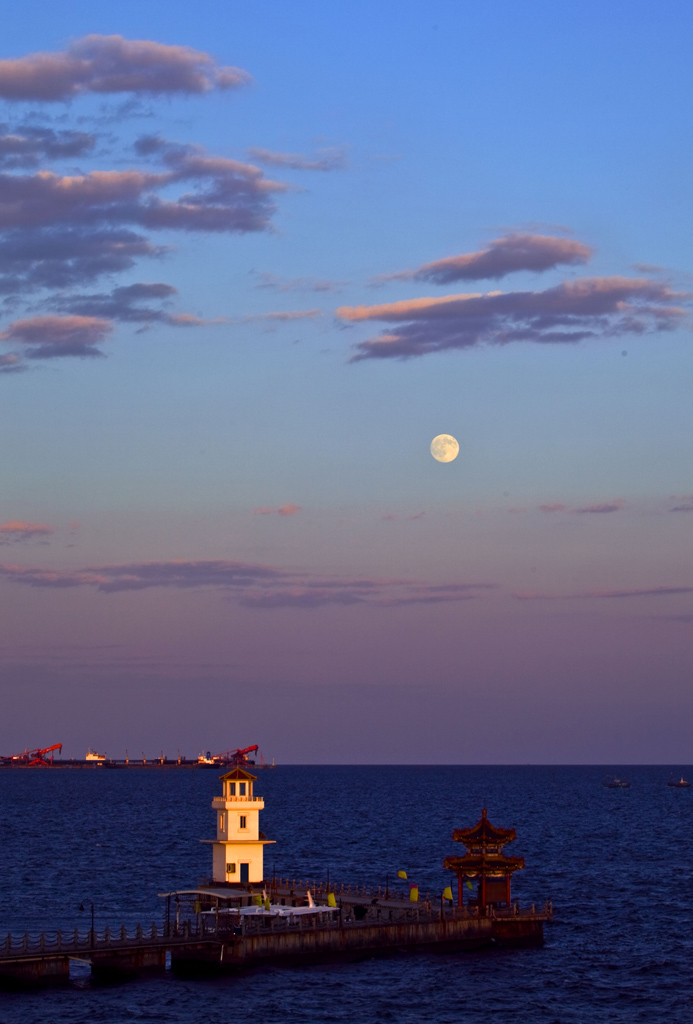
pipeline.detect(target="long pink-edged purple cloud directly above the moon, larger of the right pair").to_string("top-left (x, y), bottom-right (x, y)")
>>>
top-left (337, 278), bottom-right (691, 362)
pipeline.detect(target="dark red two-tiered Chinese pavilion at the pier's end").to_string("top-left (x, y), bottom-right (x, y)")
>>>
top-left (443, 807), bottom-right (524, 913)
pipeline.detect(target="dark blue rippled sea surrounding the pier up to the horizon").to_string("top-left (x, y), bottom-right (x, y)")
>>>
top-left (0, 766), bottom-right (693, 1024)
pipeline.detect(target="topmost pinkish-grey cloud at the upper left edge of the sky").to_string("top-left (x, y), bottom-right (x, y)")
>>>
top-left (0, 35), bottom-right (250, 101)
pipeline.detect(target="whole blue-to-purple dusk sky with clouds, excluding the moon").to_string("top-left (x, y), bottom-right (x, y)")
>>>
top-left (0, 0), bottom-right (693, 765)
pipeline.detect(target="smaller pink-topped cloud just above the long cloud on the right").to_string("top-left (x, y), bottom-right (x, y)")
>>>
top-left (372, 231), bottom-right (592, 285)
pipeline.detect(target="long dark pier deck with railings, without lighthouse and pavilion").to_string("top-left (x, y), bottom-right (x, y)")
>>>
top-left (0, 901), bottom-right (553, 987)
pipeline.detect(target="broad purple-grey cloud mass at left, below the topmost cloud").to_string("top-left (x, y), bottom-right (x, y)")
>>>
top-left (0, 136), bottom-right (286, 315)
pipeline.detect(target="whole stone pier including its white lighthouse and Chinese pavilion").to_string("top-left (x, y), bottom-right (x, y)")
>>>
top-left (0, 764), bottom-right (553, 987)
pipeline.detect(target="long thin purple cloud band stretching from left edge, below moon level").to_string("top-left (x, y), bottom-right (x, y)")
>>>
top-left (0, 560), bottom-right (494, 609)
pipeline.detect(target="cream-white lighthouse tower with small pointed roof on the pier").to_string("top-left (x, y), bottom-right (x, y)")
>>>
top-left (203, 765), bottom-right (274, 885)
